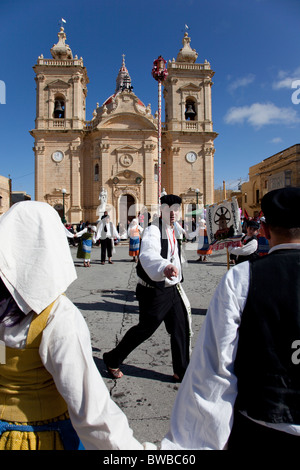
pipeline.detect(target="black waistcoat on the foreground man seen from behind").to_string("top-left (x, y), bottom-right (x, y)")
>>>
top-left (235, 249), bottom-right (300, 424)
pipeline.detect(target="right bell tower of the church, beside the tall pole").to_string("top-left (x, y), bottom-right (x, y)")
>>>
top-left (162, 32), bottom-right (218, 205)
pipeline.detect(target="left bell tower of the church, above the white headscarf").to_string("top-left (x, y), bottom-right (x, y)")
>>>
top-left (30, 27), bottom-right (89, 223)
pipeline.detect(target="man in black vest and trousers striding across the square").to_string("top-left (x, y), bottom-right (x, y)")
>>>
top-left (103, 194), bottom-right (189, 381)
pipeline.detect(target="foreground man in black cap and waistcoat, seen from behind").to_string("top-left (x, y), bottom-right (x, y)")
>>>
top-left (162, 188), bottom-right (300, 451)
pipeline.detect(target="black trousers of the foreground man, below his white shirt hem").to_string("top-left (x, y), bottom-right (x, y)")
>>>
top-left (227, 412), bottom-right (300, 452)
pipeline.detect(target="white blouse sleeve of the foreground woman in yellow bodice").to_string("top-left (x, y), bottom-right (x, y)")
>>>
top-left (40, 296), bottom-right (143, 450)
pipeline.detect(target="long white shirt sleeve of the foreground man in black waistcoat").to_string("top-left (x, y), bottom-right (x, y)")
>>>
top-left (161, 262), bottom-right (249, 450)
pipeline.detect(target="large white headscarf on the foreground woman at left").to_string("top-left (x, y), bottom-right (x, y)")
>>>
top-left (0, 201), bottom-right (77, 313)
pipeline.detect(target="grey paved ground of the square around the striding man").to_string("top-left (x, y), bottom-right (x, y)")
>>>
top-left (67, 242), bottom-right (227, 444)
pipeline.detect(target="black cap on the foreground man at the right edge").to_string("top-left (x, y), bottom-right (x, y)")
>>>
top-left (261, 188), bottom-right (300, 228)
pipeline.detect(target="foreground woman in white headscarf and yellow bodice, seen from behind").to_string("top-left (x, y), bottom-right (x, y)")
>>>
top-left (0, 201), bottom-right (153, 450)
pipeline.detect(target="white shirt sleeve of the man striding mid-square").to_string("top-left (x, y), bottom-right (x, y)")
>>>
top-left (139, 225), bottom-right (170, 282)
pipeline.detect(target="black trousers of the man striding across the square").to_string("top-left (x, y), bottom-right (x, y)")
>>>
top-left (105, 284), bottom-right (189, 378)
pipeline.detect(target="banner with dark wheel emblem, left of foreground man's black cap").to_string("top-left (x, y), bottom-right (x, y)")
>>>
top-left (206, 197), bottom-right (243, 250)
